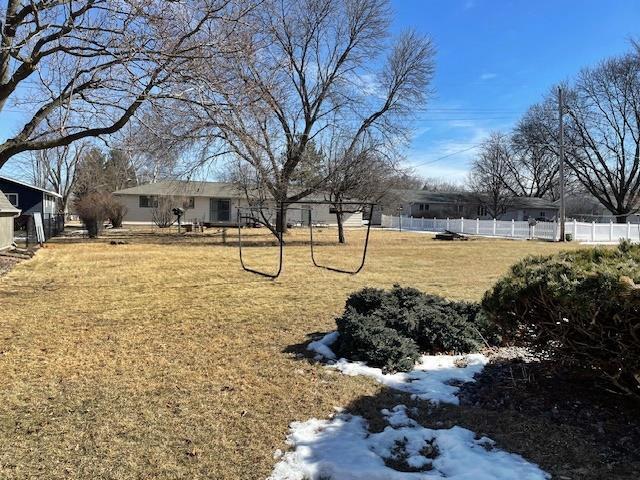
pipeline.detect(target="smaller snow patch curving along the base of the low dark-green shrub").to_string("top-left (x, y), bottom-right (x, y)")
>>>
top-left (307, 332), bottom-right (488, 405)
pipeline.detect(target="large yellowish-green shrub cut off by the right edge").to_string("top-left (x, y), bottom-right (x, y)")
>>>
top-left (482, 242), bottom-right (640, 395)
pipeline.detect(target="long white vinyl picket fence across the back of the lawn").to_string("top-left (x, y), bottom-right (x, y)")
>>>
top-left (382, 215), bottom-right (640, 242)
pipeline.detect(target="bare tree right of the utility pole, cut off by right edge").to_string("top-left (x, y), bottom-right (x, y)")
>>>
top-left (567, 54), bottom-right (640, 223)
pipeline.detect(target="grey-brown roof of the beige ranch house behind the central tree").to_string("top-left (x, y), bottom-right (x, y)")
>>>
top-left (113, 180), bottom-right (241, 198)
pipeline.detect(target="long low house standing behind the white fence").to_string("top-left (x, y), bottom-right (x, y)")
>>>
top-left (373, 190), bottom-right (558, 224)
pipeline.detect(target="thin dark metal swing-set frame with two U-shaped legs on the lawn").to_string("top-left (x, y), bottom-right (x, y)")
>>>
top-left (237, 200), bottom-right (376, 280)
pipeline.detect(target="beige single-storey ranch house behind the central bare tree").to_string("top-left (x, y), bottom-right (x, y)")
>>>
top-left (113, 180), bottom-right (362, 226)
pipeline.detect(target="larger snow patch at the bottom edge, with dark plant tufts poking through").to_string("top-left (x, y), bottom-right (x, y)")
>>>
top-left (269, 405), bottom-right (549, 480)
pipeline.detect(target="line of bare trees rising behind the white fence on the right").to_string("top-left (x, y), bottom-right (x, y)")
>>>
top-left (469, 44), bottom-right (640, 223)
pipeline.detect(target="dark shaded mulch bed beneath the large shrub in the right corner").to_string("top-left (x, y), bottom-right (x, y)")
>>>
top-left (417, 358), bottom-right (640, 480)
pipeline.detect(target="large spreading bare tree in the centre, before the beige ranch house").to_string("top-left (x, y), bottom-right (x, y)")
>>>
top-left (182, 0), bottom-right (434, 232)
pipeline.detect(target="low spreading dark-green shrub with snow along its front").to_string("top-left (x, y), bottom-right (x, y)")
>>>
top-left (334, 285), bottom-right (497, 371)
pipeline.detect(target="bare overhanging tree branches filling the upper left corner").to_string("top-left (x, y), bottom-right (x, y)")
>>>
top-left (0, 0), bottom-right (249, 168)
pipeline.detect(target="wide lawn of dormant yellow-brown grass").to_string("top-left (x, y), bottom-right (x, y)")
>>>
top-left (0, 230), bottom-right (580, 479)
